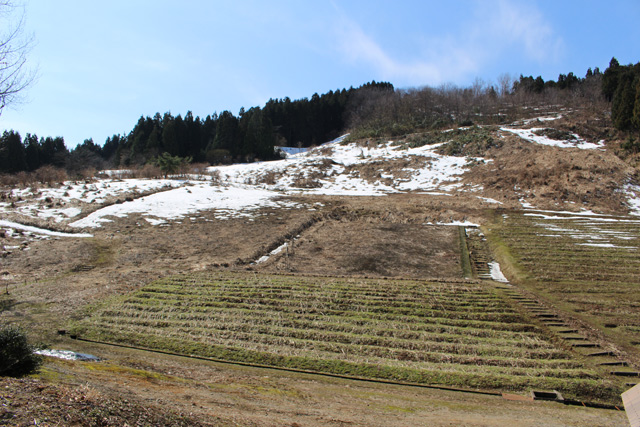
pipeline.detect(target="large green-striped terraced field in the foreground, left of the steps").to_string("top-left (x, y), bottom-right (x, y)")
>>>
top-left (69, 273), bottom-right (620, 401)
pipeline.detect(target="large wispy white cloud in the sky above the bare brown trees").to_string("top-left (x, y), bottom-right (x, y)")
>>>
top-left (334, 0), bottom-right (564, 86)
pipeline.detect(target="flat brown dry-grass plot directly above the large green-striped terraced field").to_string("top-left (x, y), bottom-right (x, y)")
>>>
top-left (260, 217), bottom-right (462, 277)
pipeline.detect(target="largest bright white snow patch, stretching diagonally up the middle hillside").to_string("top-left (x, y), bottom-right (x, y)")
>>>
top-left (69, 139), bottom-right (477, 228)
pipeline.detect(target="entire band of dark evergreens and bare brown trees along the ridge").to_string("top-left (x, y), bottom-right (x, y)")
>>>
top-left (0, 58), bottom-right (640, 176)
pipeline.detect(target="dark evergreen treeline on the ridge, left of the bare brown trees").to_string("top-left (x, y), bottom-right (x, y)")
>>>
top-left (0, 81), bottom-right (394, 174)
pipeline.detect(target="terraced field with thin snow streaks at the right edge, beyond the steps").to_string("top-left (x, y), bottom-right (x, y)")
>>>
top-left (492, 211), bottom-right (640, 353)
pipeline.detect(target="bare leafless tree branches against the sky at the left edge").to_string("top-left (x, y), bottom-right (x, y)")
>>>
top-left (0, 0), bottom-right (35, 114)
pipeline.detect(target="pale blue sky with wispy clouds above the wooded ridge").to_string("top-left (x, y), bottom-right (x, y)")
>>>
top-left (0, 0), bottom-right (640, 148)
